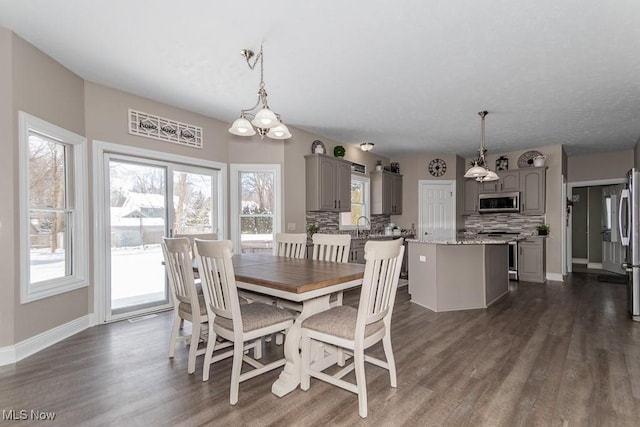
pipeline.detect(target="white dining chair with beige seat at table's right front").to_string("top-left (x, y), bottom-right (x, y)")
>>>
top-left (300, 239), bottom-right (404, 418)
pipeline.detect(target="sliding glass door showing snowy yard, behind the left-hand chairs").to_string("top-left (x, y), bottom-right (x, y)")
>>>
top-left (105, 154), bottom-right (219, 320)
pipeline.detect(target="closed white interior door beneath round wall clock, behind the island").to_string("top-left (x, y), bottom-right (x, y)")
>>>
top-left (418, 181), bottom-right (456, 239)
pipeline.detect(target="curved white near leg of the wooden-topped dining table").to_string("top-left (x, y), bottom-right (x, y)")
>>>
top-left (271, 295), bottom-right (329, 397)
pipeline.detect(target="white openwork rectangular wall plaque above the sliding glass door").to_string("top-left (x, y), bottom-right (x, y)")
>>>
top-left (129, 109), bottom-right (202, 148)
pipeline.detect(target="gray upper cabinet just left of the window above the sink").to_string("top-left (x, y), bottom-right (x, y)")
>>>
top-left (304, 154), bottom-right (351, 212)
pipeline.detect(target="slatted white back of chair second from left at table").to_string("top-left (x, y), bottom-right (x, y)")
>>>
top-left (194, 238), bottom-right (242, 328)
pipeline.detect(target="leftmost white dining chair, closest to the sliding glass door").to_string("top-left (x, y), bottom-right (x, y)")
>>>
top-left (161, 237), bottom-right (231, 374)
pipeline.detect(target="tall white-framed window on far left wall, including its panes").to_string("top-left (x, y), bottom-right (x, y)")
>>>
top-left (19, 111), bottom-right (88, 304)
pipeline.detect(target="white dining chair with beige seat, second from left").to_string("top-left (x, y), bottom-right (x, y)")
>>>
top-left (195, 239), bottom-right (296, 405)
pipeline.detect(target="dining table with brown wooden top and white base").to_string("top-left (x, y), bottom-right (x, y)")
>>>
top-left (233, 254), bottom-right (365, 397)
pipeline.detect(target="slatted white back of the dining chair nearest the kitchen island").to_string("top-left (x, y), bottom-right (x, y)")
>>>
top-left (356, 239), bottom-right (404, 337)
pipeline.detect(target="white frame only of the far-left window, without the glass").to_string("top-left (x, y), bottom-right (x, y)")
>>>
top-left (18, 111), bottom-right (89, 304)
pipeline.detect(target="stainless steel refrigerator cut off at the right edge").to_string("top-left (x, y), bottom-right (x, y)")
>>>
top-left (618, 168), bottom-right (640, 321)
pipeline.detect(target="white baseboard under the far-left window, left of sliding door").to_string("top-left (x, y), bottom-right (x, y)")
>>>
top-left (0, 313), bottom-right (96, 366)
